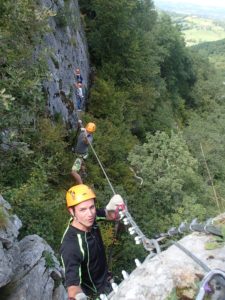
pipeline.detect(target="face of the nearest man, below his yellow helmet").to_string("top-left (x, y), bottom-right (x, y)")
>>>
top-left (75, 199), bottom-right (96, 230)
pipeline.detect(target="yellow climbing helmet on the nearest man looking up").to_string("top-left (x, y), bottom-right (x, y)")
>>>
top-left (66, 184), bottom-right (96, 207)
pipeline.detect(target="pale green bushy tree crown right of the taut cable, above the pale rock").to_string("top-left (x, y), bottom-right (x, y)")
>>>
top-left (128, 132), bottom-right (213, 232)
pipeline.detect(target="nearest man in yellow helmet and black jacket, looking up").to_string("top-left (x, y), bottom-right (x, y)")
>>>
top-left (60, 184), bottom-right (124, 300)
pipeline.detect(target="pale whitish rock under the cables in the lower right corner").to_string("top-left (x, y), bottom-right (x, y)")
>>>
top-left (110, 225), bottom-right (225, 300)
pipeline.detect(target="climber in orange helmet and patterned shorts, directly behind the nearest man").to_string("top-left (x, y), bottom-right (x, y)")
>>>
top-left (71, 122), bottom-right (96, 184)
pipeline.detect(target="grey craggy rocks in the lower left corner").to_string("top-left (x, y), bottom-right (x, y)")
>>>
top-left (0, 196), bottom-right (67, 300)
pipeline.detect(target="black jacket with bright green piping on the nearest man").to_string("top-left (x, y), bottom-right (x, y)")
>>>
top-left (60, 210), bottom-right (108, 295)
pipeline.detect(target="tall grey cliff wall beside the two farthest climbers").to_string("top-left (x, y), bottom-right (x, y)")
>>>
top-left (38, 0), bottom-right (90, 127)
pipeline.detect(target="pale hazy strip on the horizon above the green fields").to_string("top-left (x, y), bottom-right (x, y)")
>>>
top-left (154, 0), bottom-right (225, 20)
